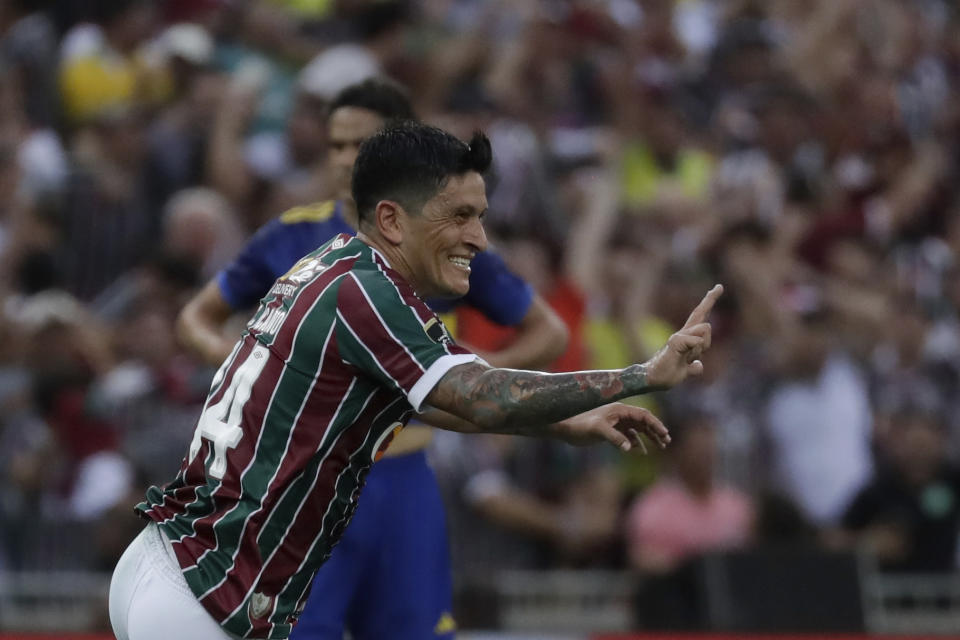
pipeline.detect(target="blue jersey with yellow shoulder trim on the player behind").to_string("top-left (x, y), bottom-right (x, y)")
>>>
top-left (217, 200), bottom-right (533, 326)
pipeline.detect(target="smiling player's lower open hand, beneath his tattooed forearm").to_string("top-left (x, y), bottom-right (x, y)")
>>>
top-left (554, 402), bottom-right (670, 453)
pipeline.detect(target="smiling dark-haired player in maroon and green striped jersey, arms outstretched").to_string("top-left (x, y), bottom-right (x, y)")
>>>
top-left (110, 123), bottom-right (723, 640)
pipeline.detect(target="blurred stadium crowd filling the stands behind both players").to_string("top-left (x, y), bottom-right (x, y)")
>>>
top-left (0, 0), bottom-right (960, 638)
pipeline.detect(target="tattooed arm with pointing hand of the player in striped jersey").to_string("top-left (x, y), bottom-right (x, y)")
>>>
top-left (426, 285), bottom-right (723, 435)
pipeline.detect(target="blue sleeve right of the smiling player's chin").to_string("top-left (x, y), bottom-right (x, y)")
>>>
top-left (430, 251), bottom-right (533, 327)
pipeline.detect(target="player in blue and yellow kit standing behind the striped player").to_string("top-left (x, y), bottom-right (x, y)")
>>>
top-left (178, 80), bottom-right (567, 640)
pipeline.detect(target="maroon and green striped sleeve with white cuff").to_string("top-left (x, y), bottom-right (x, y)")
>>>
top-left (336, 272), bottom-right (479, 411)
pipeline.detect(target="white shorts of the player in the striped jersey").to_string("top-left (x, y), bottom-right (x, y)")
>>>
top-left (110, 522), bottom-right (236, 640)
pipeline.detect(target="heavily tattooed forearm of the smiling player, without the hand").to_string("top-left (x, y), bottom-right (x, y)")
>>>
top-left (428, 363), bottom-right (654, 435)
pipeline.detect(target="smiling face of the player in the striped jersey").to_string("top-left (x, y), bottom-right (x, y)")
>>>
top-left (400, 171), bottom-right (487, 297)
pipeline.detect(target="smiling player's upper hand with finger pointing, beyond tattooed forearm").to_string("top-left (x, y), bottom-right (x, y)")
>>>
top-left (646, 284), bottom-right (723, 389)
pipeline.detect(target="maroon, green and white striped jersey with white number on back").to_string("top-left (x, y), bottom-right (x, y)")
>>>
top-left (136, 235), bottom-right (476, 638)
